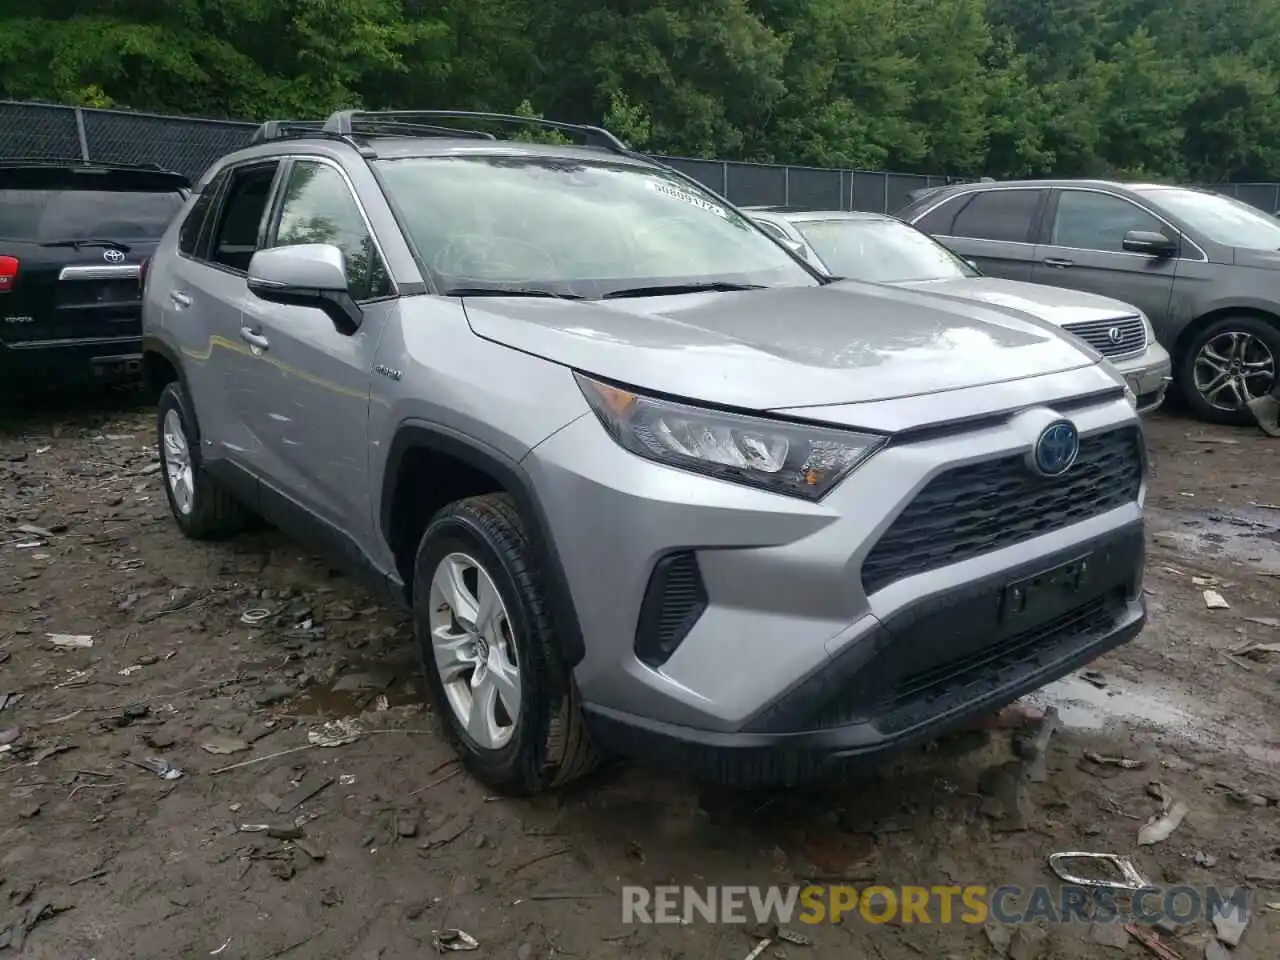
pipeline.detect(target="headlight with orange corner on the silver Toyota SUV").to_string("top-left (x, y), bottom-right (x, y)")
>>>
top-left (575, 374), bottom-right (884, 500)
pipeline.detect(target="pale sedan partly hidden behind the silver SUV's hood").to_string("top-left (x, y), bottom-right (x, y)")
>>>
top-left (749, 209), bottom-right (1172, 413)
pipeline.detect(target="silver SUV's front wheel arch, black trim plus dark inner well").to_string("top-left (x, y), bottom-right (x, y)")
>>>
top-left (378, 421), bottom-right (586, 668)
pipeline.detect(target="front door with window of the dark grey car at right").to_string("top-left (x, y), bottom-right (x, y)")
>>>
top-left (1032, 188), bottom-right (1181, 324)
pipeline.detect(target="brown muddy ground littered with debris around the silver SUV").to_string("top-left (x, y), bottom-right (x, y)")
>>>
top-left (0, 403), bottom-right (1280, 960)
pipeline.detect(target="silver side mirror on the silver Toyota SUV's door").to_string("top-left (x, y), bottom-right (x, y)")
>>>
top-left (248, 243), bottom-right (362, 334)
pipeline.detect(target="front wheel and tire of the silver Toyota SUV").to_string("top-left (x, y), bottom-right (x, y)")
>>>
top-left (413, 494), bottom-right (598, 796)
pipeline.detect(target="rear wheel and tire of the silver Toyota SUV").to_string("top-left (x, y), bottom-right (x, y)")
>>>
top-left (156, 381), bottom-right (251, 540)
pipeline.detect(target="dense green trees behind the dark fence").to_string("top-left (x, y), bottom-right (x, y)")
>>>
top-left (0, 0), bottom-right (1280, 180)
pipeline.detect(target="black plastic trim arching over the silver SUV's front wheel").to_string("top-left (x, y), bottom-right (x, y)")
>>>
top-left (379, 421), bottom-right (586, 667)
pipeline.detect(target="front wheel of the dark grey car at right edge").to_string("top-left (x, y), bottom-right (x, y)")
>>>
top-left (1178, 315), bottom-right (1280, 426)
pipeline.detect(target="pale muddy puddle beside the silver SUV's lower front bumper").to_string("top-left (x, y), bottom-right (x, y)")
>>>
top-left (1030, 676), bottom-right (1280, 764)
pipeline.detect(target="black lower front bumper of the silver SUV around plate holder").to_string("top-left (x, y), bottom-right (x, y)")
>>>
top-left (586, 521), bottom-right (1146, 786)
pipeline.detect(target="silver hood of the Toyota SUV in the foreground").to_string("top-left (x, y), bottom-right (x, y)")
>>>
top-left (463, 282), bottom-right (1097, 410)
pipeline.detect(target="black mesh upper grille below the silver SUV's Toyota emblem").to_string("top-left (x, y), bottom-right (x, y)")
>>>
top-left (863, 428), bottom-right (1142, 594)
